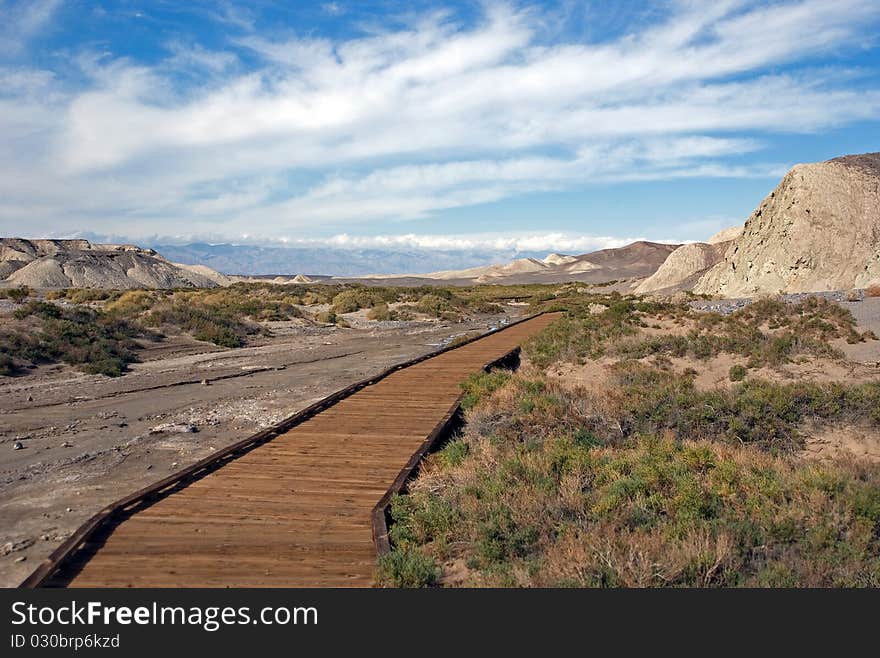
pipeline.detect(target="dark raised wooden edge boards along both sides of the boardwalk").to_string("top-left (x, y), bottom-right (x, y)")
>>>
top-left (19, 311), bottom-right (545, 589)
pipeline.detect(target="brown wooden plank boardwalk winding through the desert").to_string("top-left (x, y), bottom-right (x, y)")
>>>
top-left (37, 314), bottom-right (557, 587)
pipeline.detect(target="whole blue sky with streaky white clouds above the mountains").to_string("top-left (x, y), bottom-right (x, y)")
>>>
top-left (0, 0), bottom-right (880, 252)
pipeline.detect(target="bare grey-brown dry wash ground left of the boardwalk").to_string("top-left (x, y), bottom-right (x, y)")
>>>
top-left (0, 318), bottom-right (516, 587)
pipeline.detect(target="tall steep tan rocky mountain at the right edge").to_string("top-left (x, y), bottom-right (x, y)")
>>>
top-left (694, 153), bottom-right (880, 297)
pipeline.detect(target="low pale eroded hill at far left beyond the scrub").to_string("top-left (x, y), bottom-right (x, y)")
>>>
top-left (0, 238), bottom-right (229, 289)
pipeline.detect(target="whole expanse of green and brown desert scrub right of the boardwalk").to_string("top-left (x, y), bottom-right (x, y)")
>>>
top-left (378, 290), bottom-right (880, 587)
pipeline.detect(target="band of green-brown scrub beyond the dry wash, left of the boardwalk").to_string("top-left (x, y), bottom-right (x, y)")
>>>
top-left (0, 283), bottom-right (544, 376)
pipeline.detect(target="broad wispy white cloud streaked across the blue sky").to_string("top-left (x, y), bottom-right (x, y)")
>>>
top-left (0, 0), bottom-right (880, 237)
